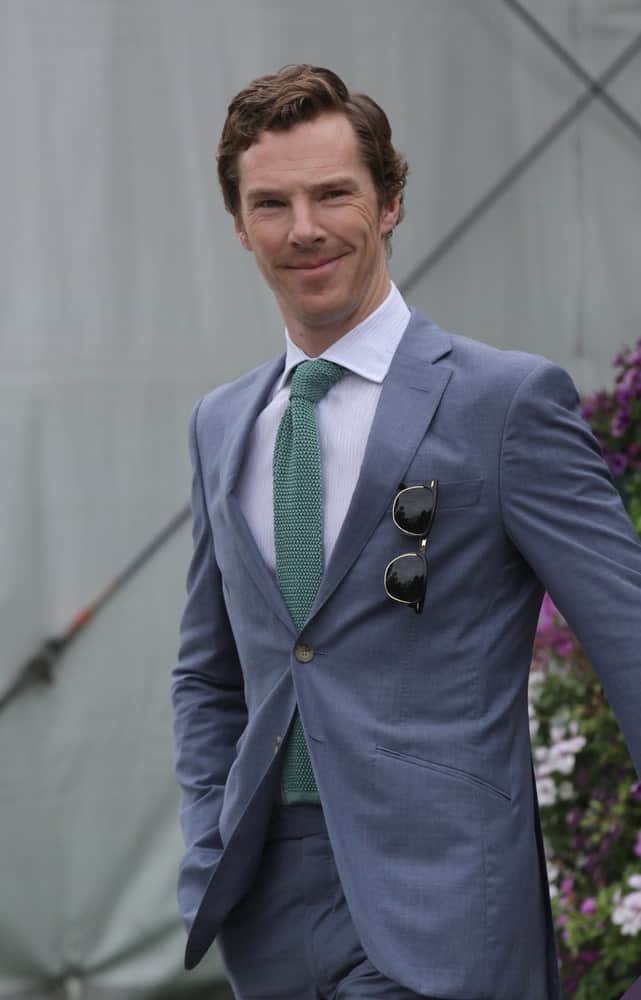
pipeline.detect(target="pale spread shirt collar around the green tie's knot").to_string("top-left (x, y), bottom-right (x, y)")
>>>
top-left (274, 281), bottom-right (410, 392)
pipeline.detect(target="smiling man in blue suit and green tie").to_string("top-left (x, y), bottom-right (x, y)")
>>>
top-left (173, 66), bottom-right (641, 1000)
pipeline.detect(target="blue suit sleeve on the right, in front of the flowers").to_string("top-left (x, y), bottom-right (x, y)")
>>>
top-left (500, 361), bottom-right (641, 774)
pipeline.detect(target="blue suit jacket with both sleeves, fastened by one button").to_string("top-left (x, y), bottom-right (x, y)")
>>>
top-left (173, 312), bottom-right (641, 1000)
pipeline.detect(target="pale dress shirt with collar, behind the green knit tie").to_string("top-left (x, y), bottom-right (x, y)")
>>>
top-left (238, 283), bottom-right (410, 569)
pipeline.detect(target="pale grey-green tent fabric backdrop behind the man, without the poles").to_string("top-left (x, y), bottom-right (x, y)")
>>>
top-left (0, 0), bottom-right (641, 998)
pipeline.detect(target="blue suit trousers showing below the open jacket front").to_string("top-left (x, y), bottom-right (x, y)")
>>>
top-left (217, 805), bottom-right (437, 1000)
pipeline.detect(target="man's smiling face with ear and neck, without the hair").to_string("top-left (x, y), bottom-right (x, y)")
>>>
top-left (236, 113), bottom-right (399, 356)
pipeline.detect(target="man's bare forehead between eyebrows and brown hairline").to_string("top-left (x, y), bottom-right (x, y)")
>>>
top-left (238, 114), bottom-right (369, 195)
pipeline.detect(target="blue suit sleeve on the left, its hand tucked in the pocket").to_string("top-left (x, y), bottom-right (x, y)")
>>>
top-left (171, 404), bottom-right (247, 928)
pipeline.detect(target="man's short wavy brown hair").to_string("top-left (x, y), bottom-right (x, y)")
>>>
top-left (217, 64), bottom-right (408, 240)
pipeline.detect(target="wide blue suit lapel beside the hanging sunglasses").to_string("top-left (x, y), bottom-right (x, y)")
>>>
top-left (311, 312), bottom-right (452, 615)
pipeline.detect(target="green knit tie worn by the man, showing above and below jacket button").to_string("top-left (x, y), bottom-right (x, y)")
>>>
top-left (274, 358), bottom-right (345, 805)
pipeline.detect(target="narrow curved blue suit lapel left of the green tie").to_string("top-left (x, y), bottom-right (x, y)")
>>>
top-left (221, 356), bottom-right (296, 632)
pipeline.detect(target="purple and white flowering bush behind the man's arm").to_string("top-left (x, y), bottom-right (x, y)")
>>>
top-left (530, 341), bottom-right (641, 1000)
